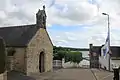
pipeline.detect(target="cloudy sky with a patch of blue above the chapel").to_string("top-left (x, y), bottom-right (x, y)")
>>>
top-left (0, 0), bottom-right (120, 48)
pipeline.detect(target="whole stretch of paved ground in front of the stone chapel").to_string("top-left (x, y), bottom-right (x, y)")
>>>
top-left (8, 68), bottom-right (116, 80)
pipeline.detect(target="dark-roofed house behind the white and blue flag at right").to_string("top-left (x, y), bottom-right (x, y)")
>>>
top-left (90, 44), bottom-right (120, 68)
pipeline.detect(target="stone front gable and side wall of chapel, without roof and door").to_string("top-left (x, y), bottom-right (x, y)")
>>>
top-left (5, 28), bottom-right (53, 73)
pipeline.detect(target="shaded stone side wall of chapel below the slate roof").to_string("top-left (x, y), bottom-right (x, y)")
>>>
top-left (7, 48), bottom-right (26, 72)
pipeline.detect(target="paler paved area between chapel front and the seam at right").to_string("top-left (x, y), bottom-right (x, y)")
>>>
top-left (32, 69), bottom-right (95, 80)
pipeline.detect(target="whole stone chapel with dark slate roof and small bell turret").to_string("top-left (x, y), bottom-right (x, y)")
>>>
top-left (0, 6), bottom-right (53, 75)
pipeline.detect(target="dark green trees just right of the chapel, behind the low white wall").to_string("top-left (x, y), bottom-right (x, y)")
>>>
top-left (53, 46), bottom-right (83, 63)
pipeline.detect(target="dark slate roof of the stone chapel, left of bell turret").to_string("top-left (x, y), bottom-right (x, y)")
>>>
top-left (0, 24), bottom-right (39, 47)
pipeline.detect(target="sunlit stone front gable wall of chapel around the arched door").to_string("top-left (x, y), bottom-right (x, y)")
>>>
top-left (26, 28), bottom-right (53, 75)
